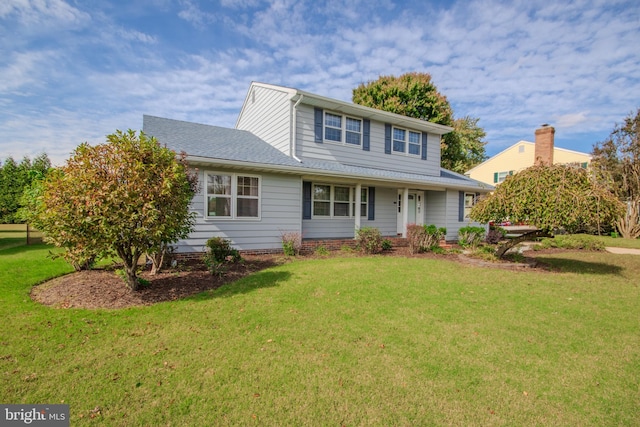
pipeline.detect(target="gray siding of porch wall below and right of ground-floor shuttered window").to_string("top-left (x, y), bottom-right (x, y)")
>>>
top-left (302, 187), bottom-right (397, 239)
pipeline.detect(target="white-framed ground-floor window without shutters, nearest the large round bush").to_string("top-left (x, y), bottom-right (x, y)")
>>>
top-left (205, 172), bottom-right (260, 219)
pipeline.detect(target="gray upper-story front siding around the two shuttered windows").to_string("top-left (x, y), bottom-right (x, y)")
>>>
top-left (296, 104), bottom-right (440, 176)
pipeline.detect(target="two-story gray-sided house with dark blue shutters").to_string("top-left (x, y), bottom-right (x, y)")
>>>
top-left (143, 82), bottom-right (493, 252)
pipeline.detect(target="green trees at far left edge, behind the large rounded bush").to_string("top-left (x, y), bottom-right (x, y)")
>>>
top-left (0, 154), bottom-right (51, 224)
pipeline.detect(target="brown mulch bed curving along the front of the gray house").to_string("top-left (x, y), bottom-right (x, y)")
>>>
top-left (31, 247), bottom-right (552, 309)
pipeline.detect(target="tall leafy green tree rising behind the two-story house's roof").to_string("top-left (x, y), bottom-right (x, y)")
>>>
top-left (352, 72), bottom-right (486, 173)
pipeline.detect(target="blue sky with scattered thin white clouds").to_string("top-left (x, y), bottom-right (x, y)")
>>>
top-left (0, 0), bottom-right (640, 165)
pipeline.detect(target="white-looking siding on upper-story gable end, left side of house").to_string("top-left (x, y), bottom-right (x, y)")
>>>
top-left (236, 86), bottom-right (291, 155)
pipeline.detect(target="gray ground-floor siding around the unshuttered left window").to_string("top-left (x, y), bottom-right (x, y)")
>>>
top-left (177, 169), bottom-right (302, 252)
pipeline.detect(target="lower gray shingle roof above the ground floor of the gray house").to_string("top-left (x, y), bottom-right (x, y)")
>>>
top-left (143, 115), bottom-right (493, 191)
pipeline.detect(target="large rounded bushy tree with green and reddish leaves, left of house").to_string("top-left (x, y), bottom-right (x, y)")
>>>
top-left (27, 130), bottom-right (197, 290)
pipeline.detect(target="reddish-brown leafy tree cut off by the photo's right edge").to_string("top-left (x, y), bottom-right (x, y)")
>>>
top-left (591, 108), bottom-right (640, 239)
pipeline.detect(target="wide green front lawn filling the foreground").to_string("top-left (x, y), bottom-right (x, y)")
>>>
top-left (0, 245), bottom-right (640, 426)
